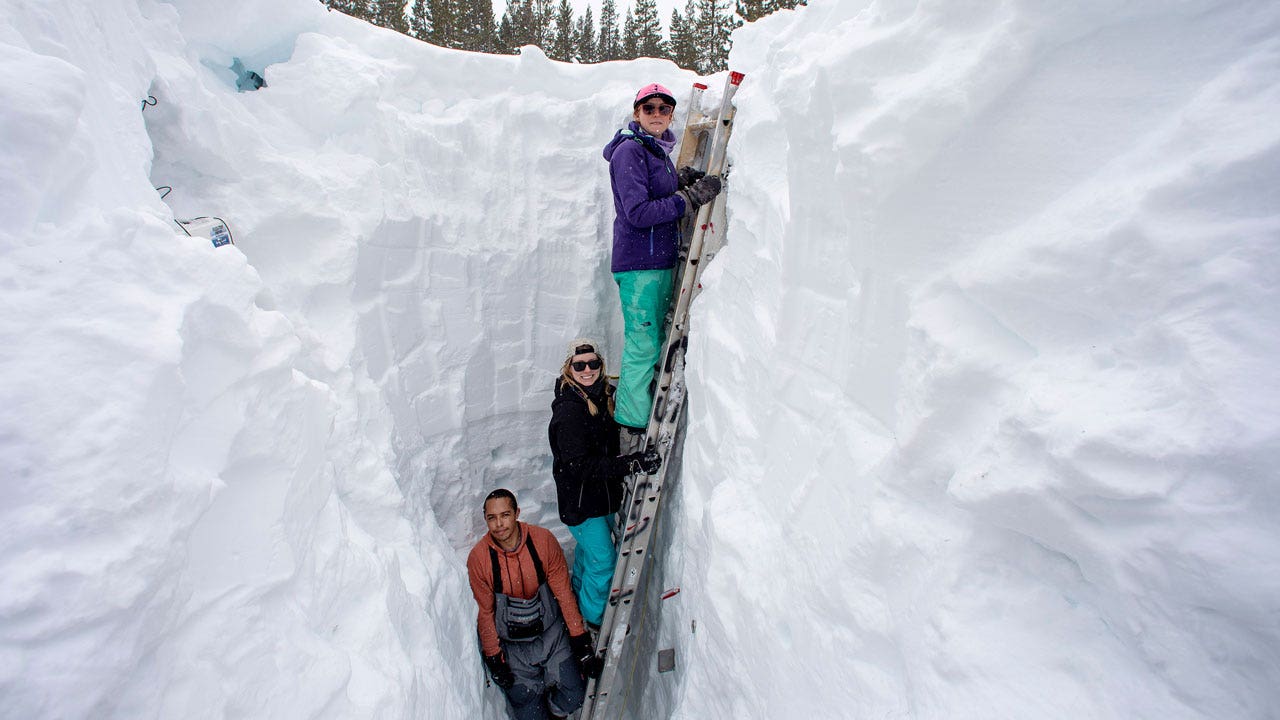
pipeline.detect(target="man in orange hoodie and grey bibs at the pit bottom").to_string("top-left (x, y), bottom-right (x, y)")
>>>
top-left (467, 489), bottom-right (600, 720)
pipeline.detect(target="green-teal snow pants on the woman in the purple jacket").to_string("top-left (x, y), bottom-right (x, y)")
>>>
top-left (613, 269), bottom-right (675, 428)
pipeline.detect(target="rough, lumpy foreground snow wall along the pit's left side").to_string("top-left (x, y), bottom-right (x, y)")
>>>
top-left (0, 1), bottom-right (481, 719)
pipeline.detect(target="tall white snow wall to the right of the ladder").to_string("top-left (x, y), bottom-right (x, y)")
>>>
top-left (671, 0), bottom-right (1280, 719)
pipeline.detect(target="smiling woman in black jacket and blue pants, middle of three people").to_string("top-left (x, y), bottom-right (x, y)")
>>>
top-left (547, 340), bottom-right (660, 626)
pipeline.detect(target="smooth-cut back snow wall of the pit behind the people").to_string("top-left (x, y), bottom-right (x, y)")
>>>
top-left (129, 2), bottom-right (701, 716)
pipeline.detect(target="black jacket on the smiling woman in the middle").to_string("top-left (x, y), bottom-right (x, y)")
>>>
top-left (547, 378), bottom-right (627, 525)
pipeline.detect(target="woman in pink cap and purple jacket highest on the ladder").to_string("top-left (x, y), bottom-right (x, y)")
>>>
top-left (604, 83), bottom-right (721, 432)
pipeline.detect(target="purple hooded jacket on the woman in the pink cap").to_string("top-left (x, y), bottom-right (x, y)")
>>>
top-left (604, 122), bottom-right (685, 273)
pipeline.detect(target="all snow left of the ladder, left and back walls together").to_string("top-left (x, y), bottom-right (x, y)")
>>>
top-left (0, 0), bottom-right (687, 719)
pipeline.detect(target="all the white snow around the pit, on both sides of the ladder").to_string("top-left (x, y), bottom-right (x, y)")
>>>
top-left (0, 0), bottom-right (1280, 719)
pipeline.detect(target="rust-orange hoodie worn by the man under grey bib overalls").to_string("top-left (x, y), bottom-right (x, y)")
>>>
top-left (467, 523), bottom-right (586, 656)
